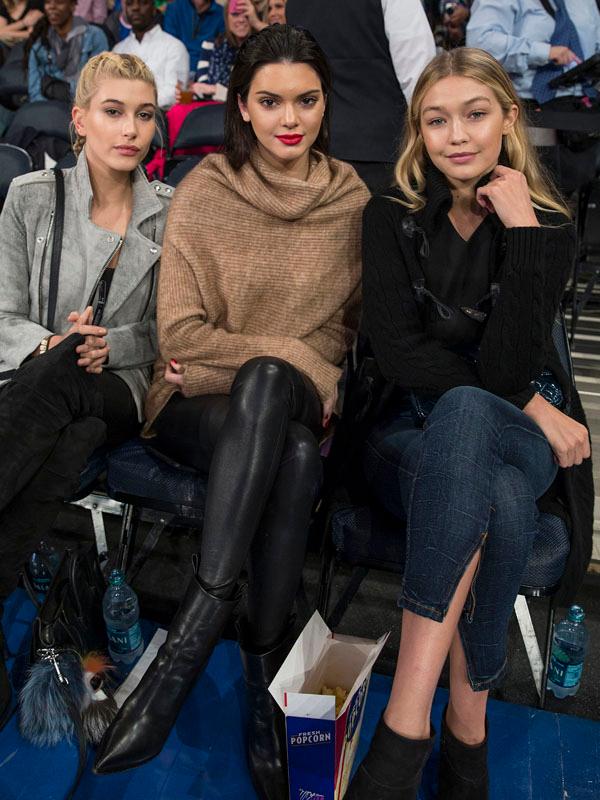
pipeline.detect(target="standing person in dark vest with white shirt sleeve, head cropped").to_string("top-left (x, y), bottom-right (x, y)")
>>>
top-left (286, 0), bottom-right (435, 192)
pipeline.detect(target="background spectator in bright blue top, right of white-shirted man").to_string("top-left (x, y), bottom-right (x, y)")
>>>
top-left (163, 0), bottom-right (225, 71)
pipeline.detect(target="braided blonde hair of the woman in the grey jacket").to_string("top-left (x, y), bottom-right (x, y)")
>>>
top-left (71, 51), bottom-right (158, 156)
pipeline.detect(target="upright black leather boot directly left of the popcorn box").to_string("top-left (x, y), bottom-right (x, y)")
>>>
top-left (240, 633), bottom-right (294, 800)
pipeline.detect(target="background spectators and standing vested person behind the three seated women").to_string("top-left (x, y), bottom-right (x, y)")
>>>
top-left (0, 0), bottom-right (600, 186)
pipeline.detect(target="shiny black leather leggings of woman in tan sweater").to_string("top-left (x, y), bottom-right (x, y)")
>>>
top-left (155, 357), bottom-right (321, 649)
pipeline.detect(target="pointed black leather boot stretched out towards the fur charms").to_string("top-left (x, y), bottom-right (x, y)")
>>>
top-left (94, 574), bottom-right (236, 773)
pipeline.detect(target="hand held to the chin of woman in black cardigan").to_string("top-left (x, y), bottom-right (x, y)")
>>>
top-left (476, 164), bottom-right (540, 228)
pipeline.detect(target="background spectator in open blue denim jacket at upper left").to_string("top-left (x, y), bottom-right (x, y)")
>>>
top-left (25, 0), bottom-right (109, 102)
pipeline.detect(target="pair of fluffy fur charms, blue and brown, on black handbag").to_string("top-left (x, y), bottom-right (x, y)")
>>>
top-left (19, 647), bottom-right (117, 747)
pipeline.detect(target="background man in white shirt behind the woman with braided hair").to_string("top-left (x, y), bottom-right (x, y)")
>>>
top-left (113, 0), bottom-right (190, 108)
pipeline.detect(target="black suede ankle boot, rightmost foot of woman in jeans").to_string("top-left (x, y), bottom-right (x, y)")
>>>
top-left (438, 706), bottom-right (489, 800)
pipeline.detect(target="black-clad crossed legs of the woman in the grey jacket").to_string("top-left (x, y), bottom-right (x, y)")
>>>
top-left (0, 335), bottom-right (139, 599)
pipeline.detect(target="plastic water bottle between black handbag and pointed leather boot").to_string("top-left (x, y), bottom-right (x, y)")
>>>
top-left (102, 569), bottom-right (144, 664)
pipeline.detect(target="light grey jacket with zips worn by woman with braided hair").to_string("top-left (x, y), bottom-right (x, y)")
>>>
top-left (0, 150), bottom-right (174, 421)
